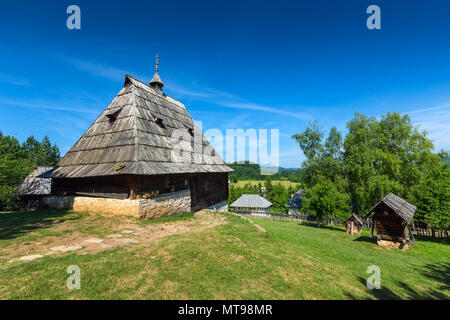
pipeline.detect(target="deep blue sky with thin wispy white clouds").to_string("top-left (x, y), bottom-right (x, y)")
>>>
top-left (0, 0), bottom-right (450, 167)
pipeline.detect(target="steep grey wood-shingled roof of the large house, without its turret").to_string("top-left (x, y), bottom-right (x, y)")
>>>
top-left (51, 75), bottom-right (233, 178)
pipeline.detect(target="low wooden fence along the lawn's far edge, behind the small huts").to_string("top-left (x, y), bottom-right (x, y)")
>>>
top-left (230, 210), bottom-right (450, 239)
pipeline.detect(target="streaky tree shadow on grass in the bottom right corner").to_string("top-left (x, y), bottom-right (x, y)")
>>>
top-left (345, 263), bottom-right (450, 300)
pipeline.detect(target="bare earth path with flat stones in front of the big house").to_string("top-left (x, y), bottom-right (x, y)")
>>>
top-left (0, 211), bottom-right (226, 262)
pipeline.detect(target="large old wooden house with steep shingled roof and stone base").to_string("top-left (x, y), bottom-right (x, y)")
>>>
top-left (43, 58), bottom-right (233, 217)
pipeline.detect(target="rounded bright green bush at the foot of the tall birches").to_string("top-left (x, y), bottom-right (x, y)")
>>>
top-left (302, 180), bottom-right (350, 223)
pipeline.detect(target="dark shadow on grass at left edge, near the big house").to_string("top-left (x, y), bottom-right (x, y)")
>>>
top-left (0, 209), bottom-right (80, 240)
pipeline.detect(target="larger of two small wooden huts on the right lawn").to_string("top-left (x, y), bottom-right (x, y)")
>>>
top-left (366, 193), bottom-right (416, 248)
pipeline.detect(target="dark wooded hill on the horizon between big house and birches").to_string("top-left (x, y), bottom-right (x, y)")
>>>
top-left (227, 161), bottom-right (302, 182)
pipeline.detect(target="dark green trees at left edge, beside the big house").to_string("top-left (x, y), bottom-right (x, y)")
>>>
top-left (0, 131), bottom-right (60, 209)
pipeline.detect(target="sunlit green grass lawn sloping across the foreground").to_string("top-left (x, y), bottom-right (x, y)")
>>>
top-left (0, 211), bottom-right (450, 299)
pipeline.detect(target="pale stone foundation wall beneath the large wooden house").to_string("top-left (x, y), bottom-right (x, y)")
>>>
top-left (43, 190), bottom-right (191, 219)
